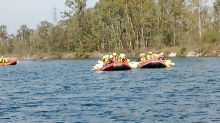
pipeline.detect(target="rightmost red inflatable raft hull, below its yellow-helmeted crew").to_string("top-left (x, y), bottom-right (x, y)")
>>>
top-left (137, 59), bottom-right (167, 68)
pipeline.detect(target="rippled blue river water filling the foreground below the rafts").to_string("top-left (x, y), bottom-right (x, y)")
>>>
top-left (0, 57), bottom-right (220, 123)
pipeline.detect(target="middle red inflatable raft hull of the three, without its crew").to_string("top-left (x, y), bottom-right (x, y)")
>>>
top-left (100, 62), bottom-right (131, 71)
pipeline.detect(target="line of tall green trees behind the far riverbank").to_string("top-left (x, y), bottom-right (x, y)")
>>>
top-left (0, 0), bottom-right (220, 57)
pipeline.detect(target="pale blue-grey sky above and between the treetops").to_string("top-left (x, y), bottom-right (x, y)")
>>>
top-left (0, 0), bottom-right (215, 34)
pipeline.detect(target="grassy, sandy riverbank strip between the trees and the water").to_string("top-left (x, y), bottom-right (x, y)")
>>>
top-left (4, 44), bottom-right (220, 59)
